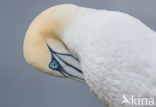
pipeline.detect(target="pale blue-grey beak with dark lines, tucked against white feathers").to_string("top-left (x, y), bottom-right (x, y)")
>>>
top-left (47, 44), bottom-right (85, 82)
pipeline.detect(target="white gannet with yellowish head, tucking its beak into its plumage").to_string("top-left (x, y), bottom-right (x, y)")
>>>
top-left (23, 4), bottom-right (156, 107)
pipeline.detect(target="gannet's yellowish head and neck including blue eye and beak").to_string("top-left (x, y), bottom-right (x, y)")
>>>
top-left (23, 4), bottom-right (89, 81)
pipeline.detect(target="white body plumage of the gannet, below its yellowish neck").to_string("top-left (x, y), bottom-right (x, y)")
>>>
top-left (63, 10), bottom-right (156, 107)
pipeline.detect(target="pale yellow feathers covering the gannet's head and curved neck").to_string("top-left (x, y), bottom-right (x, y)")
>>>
top-left (24, 4), bottom-right (86, 76)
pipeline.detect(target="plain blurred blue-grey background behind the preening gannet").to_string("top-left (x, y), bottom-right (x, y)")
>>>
top-left (0, 0), bottom-right (156, 107)
